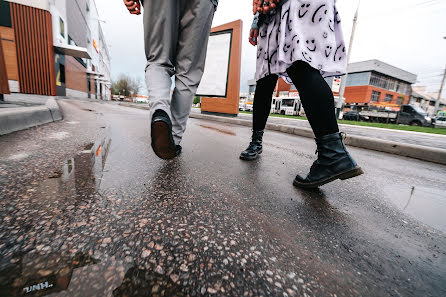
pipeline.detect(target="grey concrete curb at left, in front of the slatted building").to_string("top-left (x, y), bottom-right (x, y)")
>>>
top-left (0, 97), bottom-right (63, 135)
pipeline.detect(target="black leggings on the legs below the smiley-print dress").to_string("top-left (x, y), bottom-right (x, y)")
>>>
top-left (253, 61), bottom-right (339, 137)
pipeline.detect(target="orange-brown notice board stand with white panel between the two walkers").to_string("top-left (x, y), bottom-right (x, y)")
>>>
top-left (197, 20), bottom-right (243, 115)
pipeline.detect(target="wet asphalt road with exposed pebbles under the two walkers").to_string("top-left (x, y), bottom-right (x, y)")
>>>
top-left (0, 100), bottom-right (446, 296)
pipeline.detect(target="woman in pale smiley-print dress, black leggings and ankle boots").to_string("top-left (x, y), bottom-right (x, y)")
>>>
top-left (240, 0), bottom-right (363, 188)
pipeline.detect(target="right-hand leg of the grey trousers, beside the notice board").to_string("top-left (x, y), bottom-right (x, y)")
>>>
top-left (171, 0), bottom-right (215, 144)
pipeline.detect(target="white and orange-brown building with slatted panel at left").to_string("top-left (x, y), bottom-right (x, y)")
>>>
top-left (0, 0), bottom-right (111, 100)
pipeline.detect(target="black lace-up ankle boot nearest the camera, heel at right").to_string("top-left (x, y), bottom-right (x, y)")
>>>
top-left (293, 133), bottom-right (363, 188)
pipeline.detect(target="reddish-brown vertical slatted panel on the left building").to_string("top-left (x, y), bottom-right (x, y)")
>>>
top-left (11, 2), bottom-right (56, 96)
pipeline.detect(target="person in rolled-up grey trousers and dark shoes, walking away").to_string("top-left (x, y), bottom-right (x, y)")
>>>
top-left (124, 0), bottom-right (218, 159)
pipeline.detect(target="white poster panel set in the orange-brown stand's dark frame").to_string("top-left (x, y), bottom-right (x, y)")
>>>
top-left (197, 30), bottom-right (232, 97)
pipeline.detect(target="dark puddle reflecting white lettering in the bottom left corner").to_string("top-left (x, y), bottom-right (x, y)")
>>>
top-left (0, 253), bottom-right (133, 297)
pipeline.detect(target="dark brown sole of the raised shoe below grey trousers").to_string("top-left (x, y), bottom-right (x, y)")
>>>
top-left (152, 121), bottom-right (176, 160)
